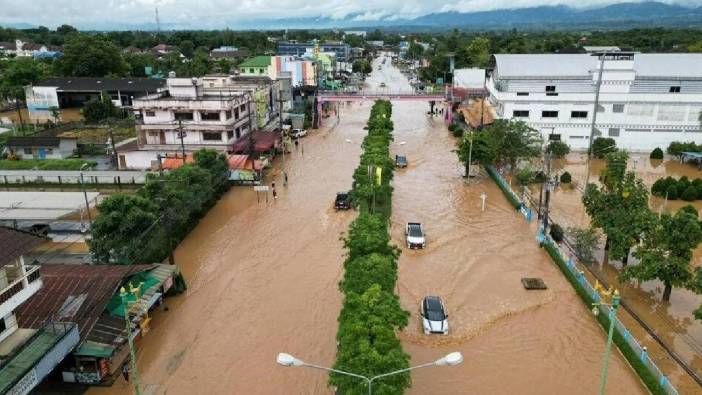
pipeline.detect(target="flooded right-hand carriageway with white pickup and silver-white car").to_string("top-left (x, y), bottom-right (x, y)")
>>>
top-left (369, 55), bottom-right (646, 394)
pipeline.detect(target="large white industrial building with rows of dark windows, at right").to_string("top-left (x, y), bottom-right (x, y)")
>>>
top-left (487, 52), bottom-right (702, 151)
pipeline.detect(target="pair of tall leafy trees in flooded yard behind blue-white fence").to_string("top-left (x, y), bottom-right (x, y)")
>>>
top-left (583, 151), bottom-right (702, 311)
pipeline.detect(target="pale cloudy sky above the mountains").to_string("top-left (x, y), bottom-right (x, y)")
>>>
top-left (0, 0), bottom-right (702, 29)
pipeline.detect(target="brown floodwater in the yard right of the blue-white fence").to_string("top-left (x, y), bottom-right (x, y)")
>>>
top-left (532, 153), bottom-right (702, 393)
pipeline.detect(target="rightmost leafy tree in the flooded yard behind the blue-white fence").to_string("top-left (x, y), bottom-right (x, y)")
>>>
top-left (620, 210), bottom-right (702, 302)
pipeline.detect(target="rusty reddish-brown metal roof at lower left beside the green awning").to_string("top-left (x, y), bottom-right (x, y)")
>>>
top-left (15, 265), bottom-right (154, 341)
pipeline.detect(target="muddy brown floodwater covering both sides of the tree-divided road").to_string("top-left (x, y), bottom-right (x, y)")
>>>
top-left (89, 56), bottom-right (646, 394)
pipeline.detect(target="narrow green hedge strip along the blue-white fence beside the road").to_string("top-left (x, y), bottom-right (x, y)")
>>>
top-left (544, 243), bottom-right (667, 395)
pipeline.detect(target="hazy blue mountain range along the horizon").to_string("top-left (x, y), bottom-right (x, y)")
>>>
top-left (0, 2), bottom-right (702, 31)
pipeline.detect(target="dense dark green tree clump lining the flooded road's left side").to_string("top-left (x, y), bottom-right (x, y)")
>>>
top-left (89, 149), bottom-right (229, 264)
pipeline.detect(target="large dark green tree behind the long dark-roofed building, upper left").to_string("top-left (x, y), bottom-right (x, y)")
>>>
top-left (56, 34), bottom-right (129, 77)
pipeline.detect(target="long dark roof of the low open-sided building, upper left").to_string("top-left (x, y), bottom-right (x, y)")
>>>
top-left (34, 77), bottom-right (166, 92)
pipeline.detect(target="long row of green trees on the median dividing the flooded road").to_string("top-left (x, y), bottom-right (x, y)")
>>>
top-left (329, 101), bottom-right (411, 395)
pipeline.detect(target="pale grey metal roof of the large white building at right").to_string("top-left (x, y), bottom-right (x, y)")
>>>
top-left (495, 53), bottom-right (702, 79)
